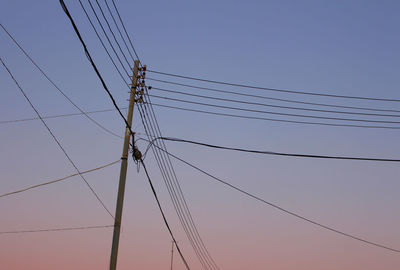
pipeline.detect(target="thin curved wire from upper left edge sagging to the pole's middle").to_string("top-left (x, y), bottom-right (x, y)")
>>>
top-left (0, 23), bottom-right (121, 138)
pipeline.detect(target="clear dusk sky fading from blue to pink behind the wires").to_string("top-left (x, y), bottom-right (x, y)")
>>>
top-left (0, 0), bottom-right (400, 270)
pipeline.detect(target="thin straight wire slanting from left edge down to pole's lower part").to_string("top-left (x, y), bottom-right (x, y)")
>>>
top-left (0, 58), bottom-right (114, 219)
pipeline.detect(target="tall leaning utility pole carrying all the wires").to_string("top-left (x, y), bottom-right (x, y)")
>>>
top-left (110, 60), bottom-right (139, 270)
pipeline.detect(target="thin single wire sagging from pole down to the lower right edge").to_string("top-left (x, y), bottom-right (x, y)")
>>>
top-left (143, 140), bottom-right (400, 253)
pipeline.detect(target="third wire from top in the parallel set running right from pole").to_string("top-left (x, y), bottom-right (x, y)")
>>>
top-left (151, 87), bottom-right (400, 117)
